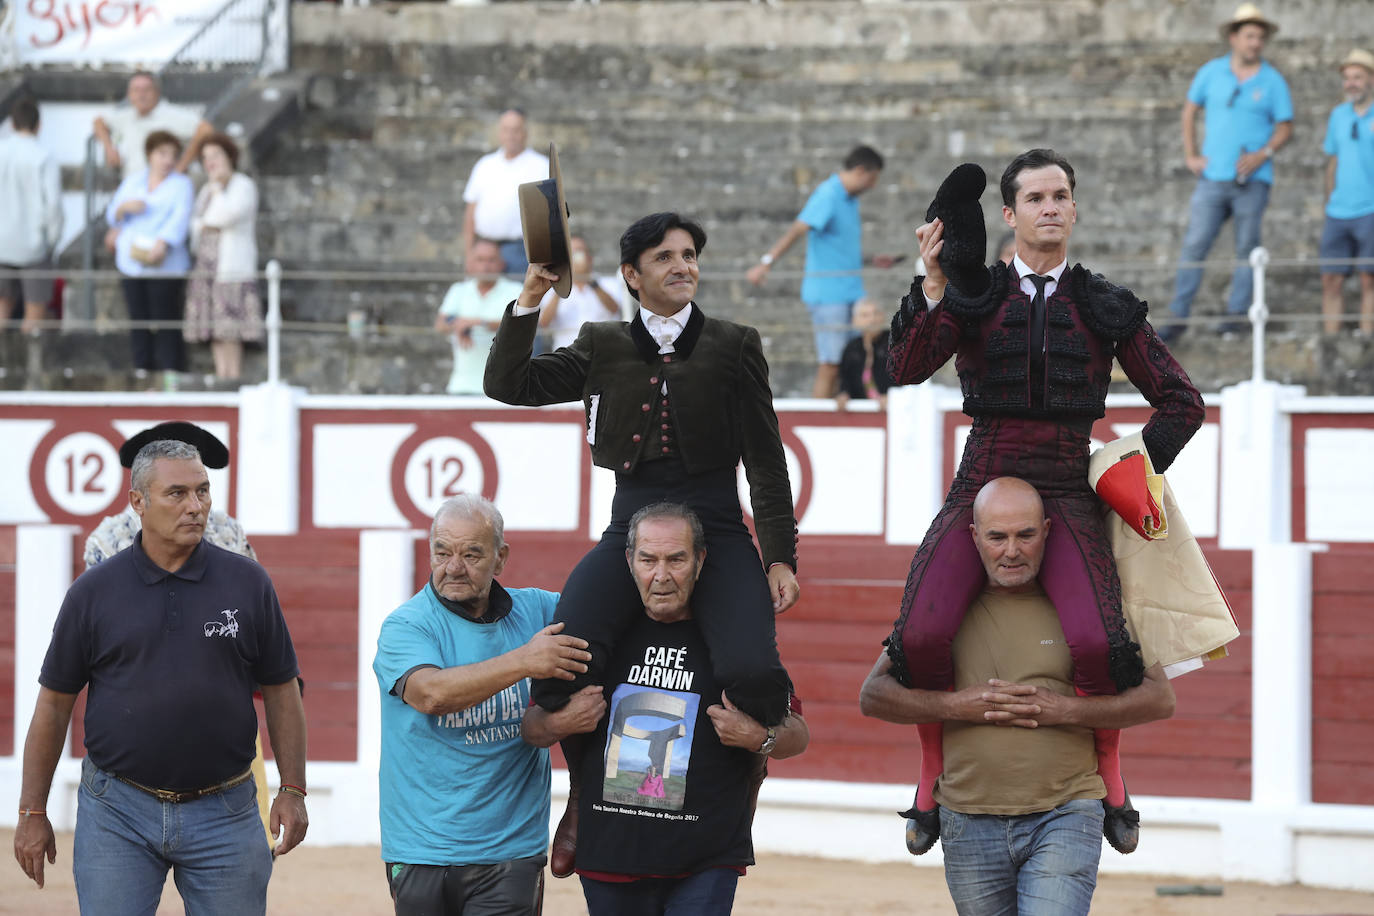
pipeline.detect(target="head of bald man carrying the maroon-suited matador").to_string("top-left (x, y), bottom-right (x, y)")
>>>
top-left (969, 477), bottom-right (1050, 593)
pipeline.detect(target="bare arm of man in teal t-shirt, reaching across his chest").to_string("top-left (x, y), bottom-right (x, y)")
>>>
top-left (401, 623), bottom-right (591, 715)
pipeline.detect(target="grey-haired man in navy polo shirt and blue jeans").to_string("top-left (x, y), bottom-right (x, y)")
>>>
top-left (14, 439), bottom-right (308, 915)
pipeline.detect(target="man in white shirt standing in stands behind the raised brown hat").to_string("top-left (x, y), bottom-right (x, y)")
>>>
top-left (463, 108), bottom-right (548, 274)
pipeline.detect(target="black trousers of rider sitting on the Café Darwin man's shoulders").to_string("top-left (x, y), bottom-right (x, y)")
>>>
top-left (532, 459), bottom-right (791, 725)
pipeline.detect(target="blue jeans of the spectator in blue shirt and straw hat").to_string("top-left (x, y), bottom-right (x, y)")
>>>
top-left (1169, 179), bottom-right (1270, 319)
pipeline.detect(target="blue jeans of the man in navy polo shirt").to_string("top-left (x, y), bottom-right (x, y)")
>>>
top-left (71, 758), bottom-right (272, 916)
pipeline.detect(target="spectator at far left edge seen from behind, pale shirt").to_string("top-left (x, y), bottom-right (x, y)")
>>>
top-left (0, 99), bottom-right (62, 332)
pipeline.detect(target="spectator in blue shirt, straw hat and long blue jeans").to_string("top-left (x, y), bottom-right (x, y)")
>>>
top-left (1158, 3), bottom-right (1293, 341)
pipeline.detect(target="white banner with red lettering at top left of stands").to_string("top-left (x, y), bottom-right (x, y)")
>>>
top-left (4, 0), bottom-right (227, 67)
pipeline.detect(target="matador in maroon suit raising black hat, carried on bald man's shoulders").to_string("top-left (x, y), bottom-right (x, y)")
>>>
top-left (886, 150), bottom-right (1204, 854)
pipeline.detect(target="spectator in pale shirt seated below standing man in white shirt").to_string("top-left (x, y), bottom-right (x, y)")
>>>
top-left (434, 238), bottom-right (521, 394)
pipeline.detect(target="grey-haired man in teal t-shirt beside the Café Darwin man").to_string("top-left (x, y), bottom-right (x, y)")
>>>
top-left (372, 494), bottom-right (591, 916)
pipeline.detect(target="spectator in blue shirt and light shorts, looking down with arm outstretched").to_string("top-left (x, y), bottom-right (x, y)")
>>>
top-left (747, 146), bottom-right (892, 398)
